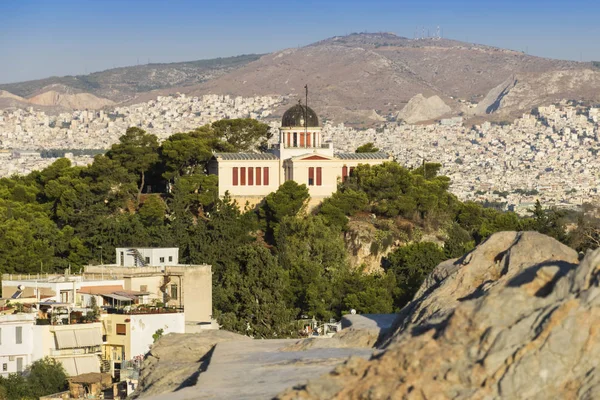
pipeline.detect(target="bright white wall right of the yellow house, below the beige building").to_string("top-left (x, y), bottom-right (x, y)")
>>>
top-left (129, 313), bottom-right (185, 358)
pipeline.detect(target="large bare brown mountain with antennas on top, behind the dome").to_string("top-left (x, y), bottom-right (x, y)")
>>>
top-left (180, 33), bottom-right (598, 122)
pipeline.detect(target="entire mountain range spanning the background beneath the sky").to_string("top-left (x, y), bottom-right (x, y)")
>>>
top-left (0, 33), bottom-right (600, 122)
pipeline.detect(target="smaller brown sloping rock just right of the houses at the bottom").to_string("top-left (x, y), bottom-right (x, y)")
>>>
top-left (135, 330), bottom-right (251, 397)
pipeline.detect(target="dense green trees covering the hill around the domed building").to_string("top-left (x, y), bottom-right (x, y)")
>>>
top-left (0, 120), bottom-right (588, 338)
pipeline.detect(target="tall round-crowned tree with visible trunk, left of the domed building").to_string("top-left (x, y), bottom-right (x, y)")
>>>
top-left (106, 127), bottom-right (159, 204)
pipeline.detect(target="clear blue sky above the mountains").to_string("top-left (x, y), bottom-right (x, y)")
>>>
top-left (0, 0), bottom-right (600, 83)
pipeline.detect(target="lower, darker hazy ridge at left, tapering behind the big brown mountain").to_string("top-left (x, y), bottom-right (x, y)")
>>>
top-left (0, 54), bottom-right (260, 101)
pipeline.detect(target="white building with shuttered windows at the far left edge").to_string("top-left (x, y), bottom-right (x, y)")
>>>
top-left (0, 313), bottom-right (35, 376)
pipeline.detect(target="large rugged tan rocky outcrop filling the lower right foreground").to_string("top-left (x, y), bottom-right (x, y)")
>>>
top-left (279, 232), bottom-right (600, 400)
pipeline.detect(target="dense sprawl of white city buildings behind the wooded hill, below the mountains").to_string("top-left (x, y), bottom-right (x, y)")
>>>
top-left (0, 95), bottom-right (600, 212)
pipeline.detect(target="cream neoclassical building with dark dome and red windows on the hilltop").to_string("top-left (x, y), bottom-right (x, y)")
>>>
top-left (209, 104), bottom-right (392, 205)
